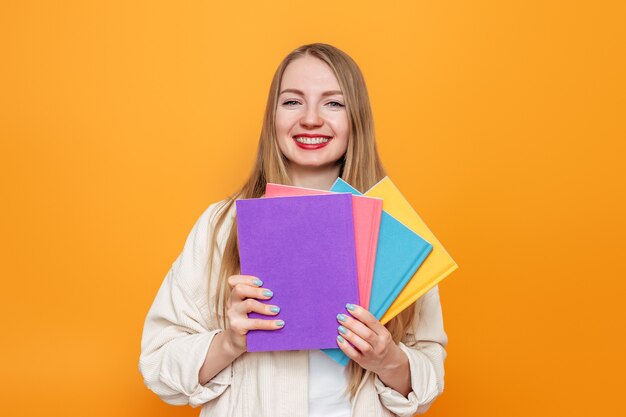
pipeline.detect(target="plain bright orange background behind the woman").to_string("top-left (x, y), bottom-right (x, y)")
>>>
top-left (0, 0), bottom-right (626, 417)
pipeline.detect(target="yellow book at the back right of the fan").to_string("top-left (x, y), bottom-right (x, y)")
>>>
top-left (364, 177), bottom-right (458, 324)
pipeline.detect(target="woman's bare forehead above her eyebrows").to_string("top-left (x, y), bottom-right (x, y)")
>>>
top-left (280, 55), bottom-right (340, 92)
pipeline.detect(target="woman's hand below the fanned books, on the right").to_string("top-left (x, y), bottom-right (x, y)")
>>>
top-left (337, 304), bottom-right (409, 381)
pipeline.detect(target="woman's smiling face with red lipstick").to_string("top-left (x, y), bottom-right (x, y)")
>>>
top-left (276, 55), bottom-right (350, 170)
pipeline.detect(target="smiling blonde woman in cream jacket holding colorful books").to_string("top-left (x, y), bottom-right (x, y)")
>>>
top-left (139, 44), bottom-right (447, 417)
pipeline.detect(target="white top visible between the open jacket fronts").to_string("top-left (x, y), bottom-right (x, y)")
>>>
top-left (309, 350), bottom-right (350, 417)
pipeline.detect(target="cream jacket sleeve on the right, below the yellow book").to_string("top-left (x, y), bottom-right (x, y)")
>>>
top-left (374, 286), bottom-right (448, 417)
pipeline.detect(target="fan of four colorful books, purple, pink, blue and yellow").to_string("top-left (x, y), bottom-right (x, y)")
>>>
top-left (236, 177), bottom-right (457, 365)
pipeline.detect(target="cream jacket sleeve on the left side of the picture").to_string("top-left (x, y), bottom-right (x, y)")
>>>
top-left (139, 203), bottom-right (232, 407)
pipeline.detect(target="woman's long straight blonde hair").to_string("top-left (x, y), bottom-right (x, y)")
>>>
top-left (209, 43), bottom-right (414, 396)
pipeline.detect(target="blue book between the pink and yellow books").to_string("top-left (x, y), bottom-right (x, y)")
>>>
top-left (322, 178), bottom-right (433, 366)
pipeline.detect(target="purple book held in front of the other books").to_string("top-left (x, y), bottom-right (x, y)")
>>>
top-left (236, 193), bottom-right (359, 352)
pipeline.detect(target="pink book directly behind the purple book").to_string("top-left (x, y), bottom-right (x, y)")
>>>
top-left (265, 183), bottom-right (383, 309)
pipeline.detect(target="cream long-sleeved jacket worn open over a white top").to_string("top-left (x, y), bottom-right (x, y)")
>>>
top-left (139, 203), bottom-right (447, 417)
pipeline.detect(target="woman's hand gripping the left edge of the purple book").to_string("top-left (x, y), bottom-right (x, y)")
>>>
top-left (224, 275), bottom-right (285, 354)
